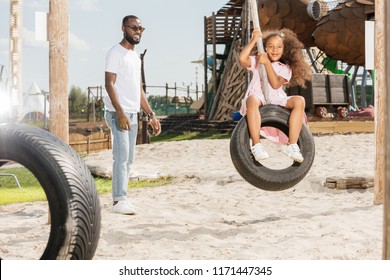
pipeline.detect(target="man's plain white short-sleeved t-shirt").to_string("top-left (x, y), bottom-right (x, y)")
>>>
top-left (104, 44), bottom-right (141, 113)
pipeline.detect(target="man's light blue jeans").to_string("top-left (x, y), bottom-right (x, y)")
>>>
top-left (105, 111), bottom-right (138, 201)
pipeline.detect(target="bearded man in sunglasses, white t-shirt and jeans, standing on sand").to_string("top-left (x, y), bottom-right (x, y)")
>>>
top-left (104, 15), bottom-right (161, 215)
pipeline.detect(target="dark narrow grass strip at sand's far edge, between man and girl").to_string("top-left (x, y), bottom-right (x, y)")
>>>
top-left (150, 131), bottom-right (231, 142)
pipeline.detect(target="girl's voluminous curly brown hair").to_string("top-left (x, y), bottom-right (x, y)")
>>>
top-left (263, 28), bottom-right (312, 88)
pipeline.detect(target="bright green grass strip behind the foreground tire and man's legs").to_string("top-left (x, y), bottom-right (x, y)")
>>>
top-left (0, 167), bottom-right (173, 205)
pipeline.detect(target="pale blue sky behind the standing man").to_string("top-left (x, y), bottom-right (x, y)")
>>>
top-left (0, 0), bottom-right (229, 94)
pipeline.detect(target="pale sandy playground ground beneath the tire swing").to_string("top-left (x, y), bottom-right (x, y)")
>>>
top-left (0, 134), bottom-right (383, 260)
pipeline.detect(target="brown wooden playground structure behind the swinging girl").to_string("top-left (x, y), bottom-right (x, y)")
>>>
top-left (204, 0), bottom-right (374, 120)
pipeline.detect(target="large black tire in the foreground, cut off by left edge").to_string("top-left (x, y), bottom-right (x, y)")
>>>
top-left (0, 124), bottom-right (101, 259)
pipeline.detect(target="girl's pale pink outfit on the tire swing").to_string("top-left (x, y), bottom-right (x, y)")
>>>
top-left (240, 56), bottom-right (292, 116)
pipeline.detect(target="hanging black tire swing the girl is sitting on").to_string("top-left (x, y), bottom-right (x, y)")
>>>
top-left (230, 105), bottom-right (315, 191)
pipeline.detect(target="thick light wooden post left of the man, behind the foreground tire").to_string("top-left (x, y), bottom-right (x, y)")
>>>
top-left (48, 0), bottom-right (69, 143)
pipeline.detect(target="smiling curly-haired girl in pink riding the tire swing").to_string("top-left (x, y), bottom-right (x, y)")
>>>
top-left (239, 28), bottom-right (312, 162)
